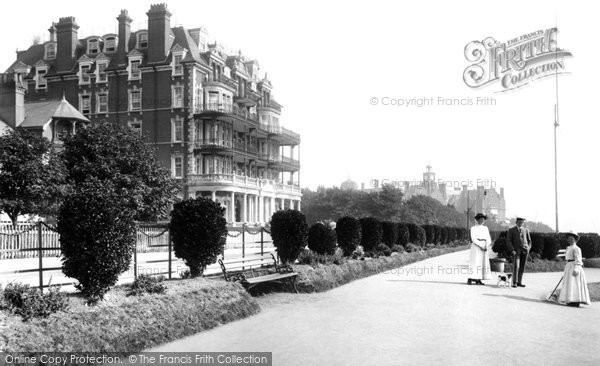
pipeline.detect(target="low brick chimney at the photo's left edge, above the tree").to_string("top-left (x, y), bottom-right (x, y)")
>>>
top-left (0, 73), bottom-right (25, 128)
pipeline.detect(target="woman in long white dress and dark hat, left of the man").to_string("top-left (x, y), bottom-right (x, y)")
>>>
top-left (467, 213), bottom-right (492, 285)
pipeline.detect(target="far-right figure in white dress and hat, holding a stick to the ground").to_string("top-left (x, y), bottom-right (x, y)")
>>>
top-left (558, 232), bottom-right (590, 307)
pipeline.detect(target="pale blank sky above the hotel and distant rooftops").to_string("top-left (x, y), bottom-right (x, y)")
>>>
top-left (0, 0), bottom-right (600, 232)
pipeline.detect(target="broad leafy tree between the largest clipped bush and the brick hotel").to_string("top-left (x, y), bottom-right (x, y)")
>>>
top-left (63, 124), bottom-right (178, 221)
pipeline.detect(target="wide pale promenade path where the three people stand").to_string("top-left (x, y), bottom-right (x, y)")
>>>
top-left (149, 251), bottom-right (600, 365)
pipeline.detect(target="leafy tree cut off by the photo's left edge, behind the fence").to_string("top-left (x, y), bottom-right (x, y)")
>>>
top-left (0, 128), bottom-right (66, 225)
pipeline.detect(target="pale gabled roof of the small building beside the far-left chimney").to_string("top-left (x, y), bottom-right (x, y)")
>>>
top-left (20, 98), bottom-right (90, 127)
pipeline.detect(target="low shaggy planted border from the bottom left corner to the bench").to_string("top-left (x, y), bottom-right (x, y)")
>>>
top-left (0, 278), bottom-right (260, 354)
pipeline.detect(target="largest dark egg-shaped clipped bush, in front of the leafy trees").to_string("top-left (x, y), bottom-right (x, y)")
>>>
top-left (56, 181), bottom-right (136, 302)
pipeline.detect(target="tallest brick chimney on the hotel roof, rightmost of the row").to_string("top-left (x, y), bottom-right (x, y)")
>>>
top-left (146, 4), bottom-right (171, 63)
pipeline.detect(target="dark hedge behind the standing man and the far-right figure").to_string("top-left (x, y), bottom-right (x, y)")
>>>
top-left (492, 231), bottom-right (600, 259)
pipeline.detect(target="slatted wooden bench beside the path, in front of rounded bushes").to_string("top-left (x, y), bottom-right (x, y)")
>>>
top-left (219, 253), bottom-right (298, 293)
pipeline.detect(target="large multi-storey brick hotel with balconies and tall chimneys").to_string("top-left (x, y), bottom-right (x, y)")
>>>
top-left (0, 4), bottom-right (301, 222)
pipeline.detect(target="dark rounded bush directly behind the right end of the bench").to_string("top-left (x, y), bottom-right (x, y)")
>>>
top-left (271, 209), bottom-right (308, 263)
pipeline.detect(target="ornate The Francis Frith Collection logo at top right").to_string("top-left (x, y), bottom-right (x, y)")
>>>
top-left (463, 28), bottom-right (572, 92)
